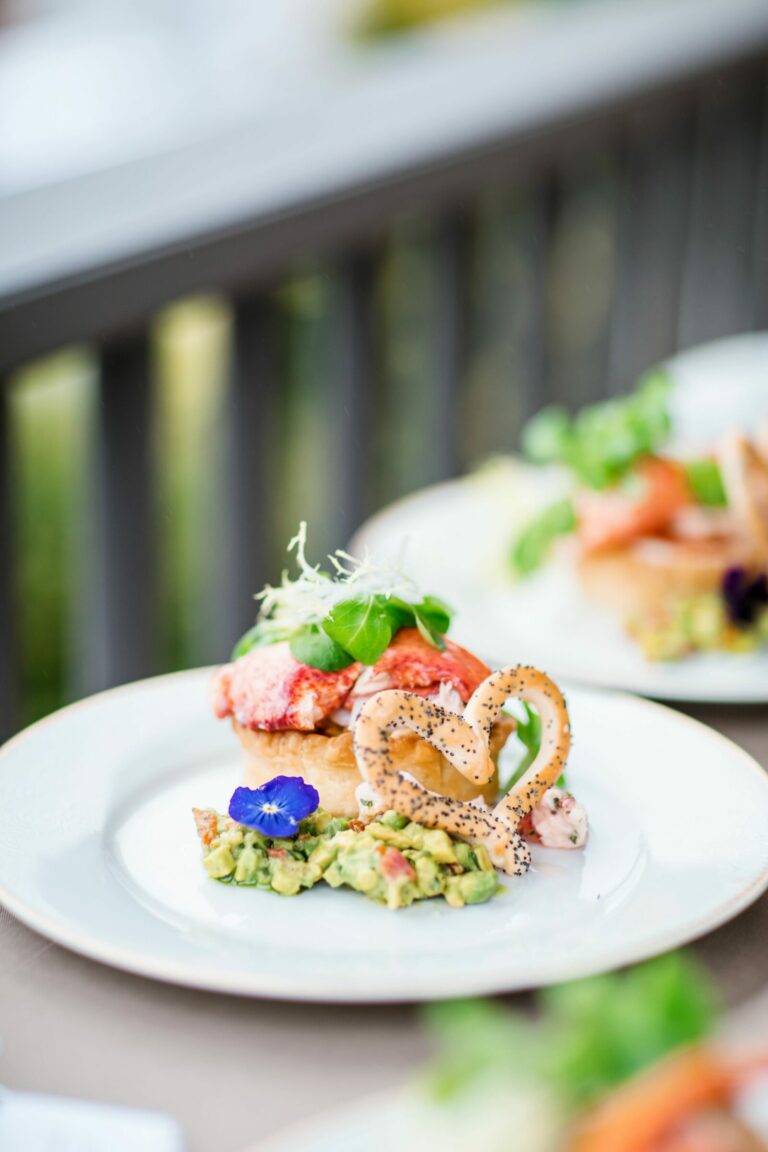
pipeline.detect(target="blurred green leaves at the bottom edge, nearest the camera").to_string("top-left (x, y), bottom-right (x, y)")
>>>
top-left (425, 953), bottom-right (715, 1111)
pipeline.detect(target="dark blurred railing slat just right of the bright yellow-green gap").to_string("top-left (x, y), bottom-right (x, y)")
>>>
top-left (215, 293), bottom-right (281, 646)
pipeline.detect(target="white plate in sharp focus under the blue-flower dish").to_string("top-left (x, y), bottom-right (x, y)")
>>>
top-left (0, 669), bottom-right (768, 1001)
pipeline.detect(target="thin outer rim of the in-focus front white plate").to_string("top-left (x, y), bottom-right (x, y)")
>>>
top-left (0, 666), bottom-right (768, 1005)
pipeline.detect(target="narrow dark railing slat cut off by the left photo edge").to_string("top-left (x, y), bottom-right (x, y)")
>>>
top-left (0, 379), bottom-right (18, 741)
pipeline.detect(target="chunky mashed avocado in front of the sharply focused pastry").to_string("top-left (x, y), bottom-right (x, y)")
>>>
top-left (196, 809), bottom-right (499, 908)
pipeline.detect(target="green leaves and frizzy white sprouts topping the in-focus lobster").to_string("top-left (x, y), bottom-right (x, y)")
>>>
top-left (233, 523), bottom-right (451, 672)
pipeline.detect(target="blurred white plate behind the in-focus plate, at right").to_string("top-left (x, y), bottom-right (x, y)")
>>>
top-left (350, 335), bottom-right (768, 704)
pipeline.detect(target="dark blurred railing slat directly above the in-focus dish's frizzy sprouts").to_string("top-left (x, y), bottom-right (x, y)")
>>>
top-left (327, 250), bottom-right (380, 546)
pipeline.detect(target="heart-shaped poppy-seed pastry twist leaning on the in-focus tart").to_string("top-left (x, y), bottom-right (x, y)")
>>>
top-left (355, 667), bottom-right (571, 876)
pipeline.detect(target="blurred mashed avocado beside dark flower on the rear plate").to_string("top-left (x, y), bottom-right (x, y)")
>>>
top-left (630, 592), bottom-right (768, 660)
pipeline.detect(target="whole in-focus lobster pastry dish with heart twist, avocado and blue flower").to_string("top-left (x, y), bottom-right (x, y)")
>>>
top-left (195, 525), bottom-right (587, 908)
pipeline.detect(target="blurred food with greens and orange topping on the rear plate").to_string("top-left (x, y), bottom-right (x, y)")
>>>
top-left (511, 372), bottom-right (768, 660)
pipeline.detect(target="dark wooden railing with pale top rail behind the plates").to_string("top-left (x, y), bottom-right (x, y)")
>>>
top-left (0, 0), bottom-right (768, 733)
